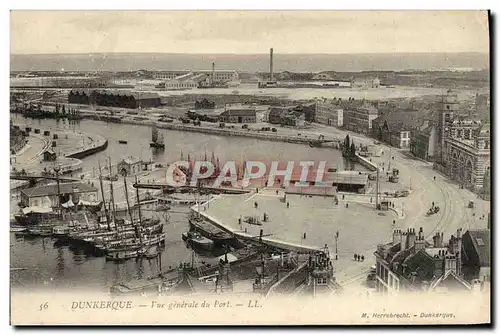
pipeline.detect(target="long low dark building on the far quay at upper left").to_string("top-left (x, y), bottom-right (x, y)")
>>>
top-left (68, 90), bottom-right (161, 109)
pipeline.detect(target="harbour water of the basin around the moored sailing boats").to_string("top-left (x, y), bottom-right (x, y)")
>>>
top-left (10, 115), bottom-right (360, 292)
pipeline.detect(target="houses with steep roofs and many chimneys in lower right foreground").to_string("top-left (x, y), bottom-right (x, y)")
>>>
top-left (374, 228), bottom-right (484, 294)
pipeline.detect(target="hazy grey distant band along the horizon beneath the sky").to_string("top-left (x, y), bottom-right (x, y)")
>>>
top-left (10, 53), bottom-right (489, 73)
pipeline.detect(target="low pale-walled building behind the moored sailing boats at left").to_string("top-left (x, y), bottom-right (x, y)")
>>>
top-left (21, 183), bottom-right (98, 208)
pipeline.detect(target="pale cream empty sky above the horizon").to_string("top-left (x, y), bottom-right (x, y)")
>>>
top-left (10, 11), bottom-right (489, 54)
